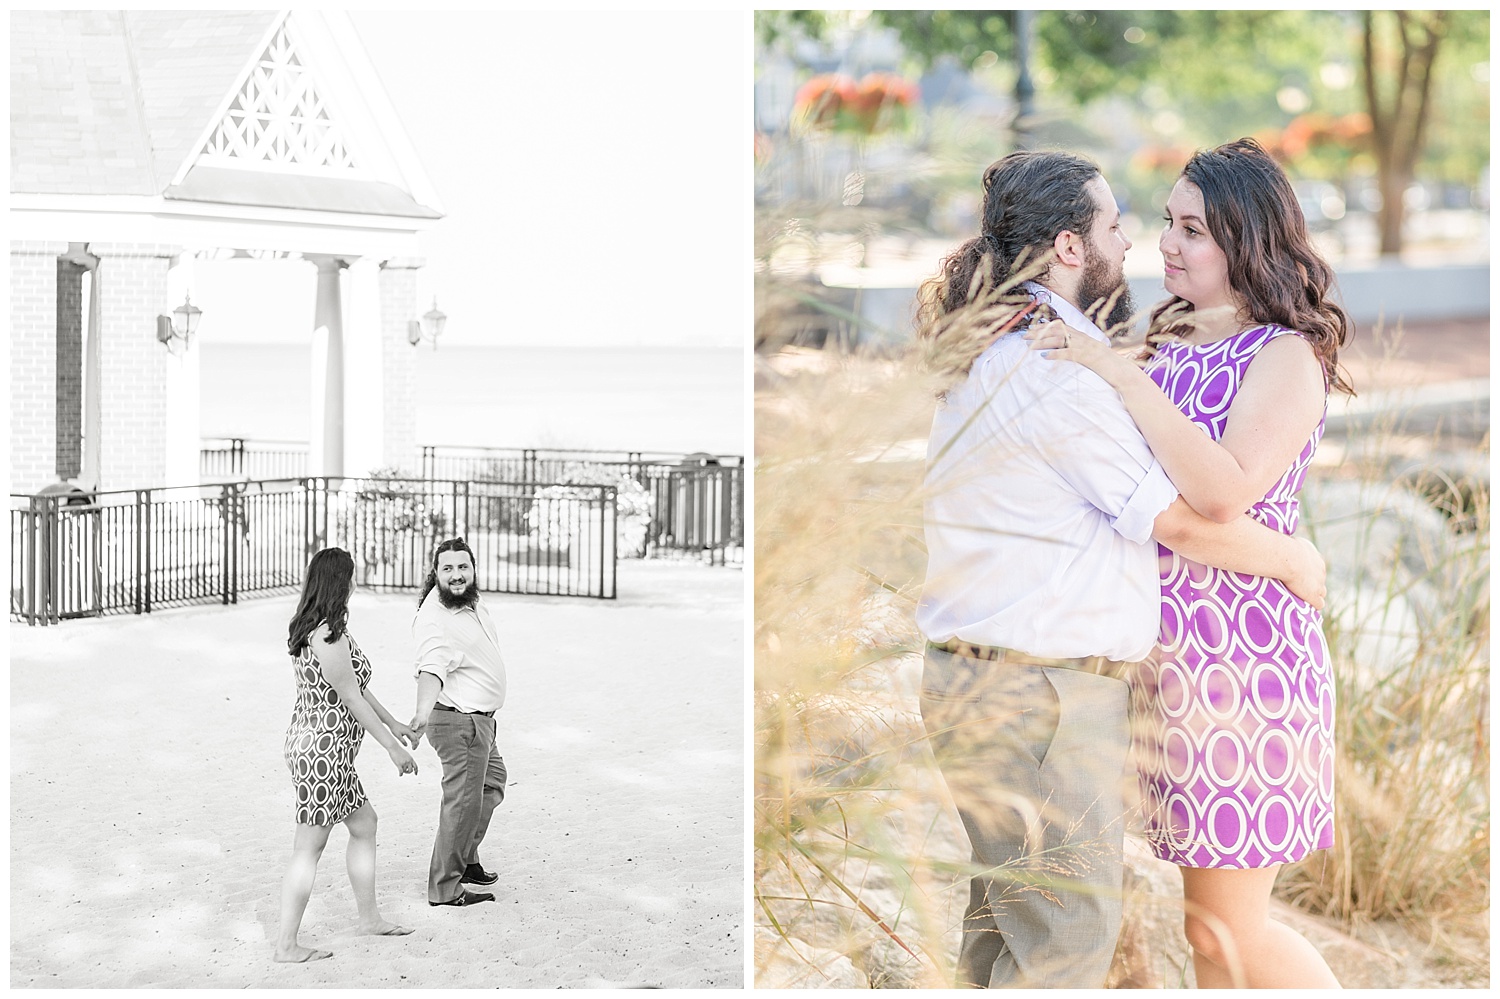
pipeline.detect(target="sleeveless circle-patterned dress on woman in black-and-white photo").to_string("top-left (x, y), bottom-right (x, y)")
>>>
top-left (282, 635), bottom-right (371, 825)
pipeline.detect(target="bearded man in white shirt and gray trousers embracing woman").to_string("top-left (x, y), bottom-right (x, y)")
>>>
top-left (917, 152), bottom-right (1325, 989)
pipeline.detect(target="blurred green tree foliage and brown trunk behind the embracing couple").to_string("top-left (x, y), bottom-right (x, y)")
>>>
top-left (858, 11), bottom-right (1490, 255)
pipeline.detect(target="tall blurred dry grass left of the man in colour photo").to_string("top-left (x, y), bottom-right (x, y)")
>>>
top-left (755, 345), bottom-right (951, 986)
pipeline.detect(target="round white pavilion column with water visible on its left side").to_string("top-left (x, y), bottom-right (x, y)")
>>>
top-left (344, 260), bottom-right (386, 477)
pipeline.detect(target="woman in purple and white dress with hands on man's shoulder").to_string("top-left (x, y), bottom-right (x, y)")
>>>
top-left (1034, 140), bottom-right (1352, 989)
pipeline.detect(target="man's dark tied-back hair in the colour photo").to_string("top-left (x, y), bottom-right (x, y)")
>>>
top-left (917, 152), bottom-right (1100, 327)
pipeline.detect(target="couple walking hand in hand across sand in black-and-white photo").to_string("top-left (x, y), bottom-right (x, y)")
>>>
top-left (275, 539), bottom-right (506, 963)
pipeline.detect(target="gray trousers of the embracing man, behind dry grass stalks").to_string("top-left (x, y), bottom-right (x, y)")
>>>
top-left (921, 648), bottom-right (1130, 989)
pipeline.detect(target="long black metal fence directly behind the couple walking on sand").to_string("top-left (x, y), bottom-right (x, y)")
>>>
top-left (11, 479), bottom-right (618, 624)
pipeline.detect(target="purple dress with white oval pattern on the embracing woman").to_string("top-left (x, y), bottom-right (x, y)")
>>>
top-left (1131, 326), bottom-right (1334, 869)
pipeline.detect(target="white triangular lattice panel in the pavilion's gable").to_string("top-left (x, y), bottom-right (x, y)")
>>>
top-left (197, 17), bottom-right (359, 174)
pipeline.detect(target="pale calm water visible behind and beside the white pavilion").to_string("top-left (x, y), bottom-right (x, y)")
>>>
top-left (194, 344), bottom-right (747, 455)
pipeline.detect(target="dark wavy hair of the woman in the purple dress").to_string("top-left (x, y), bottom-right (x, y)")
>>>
top-left (1151, 138), bottom-right (1355, 395)
